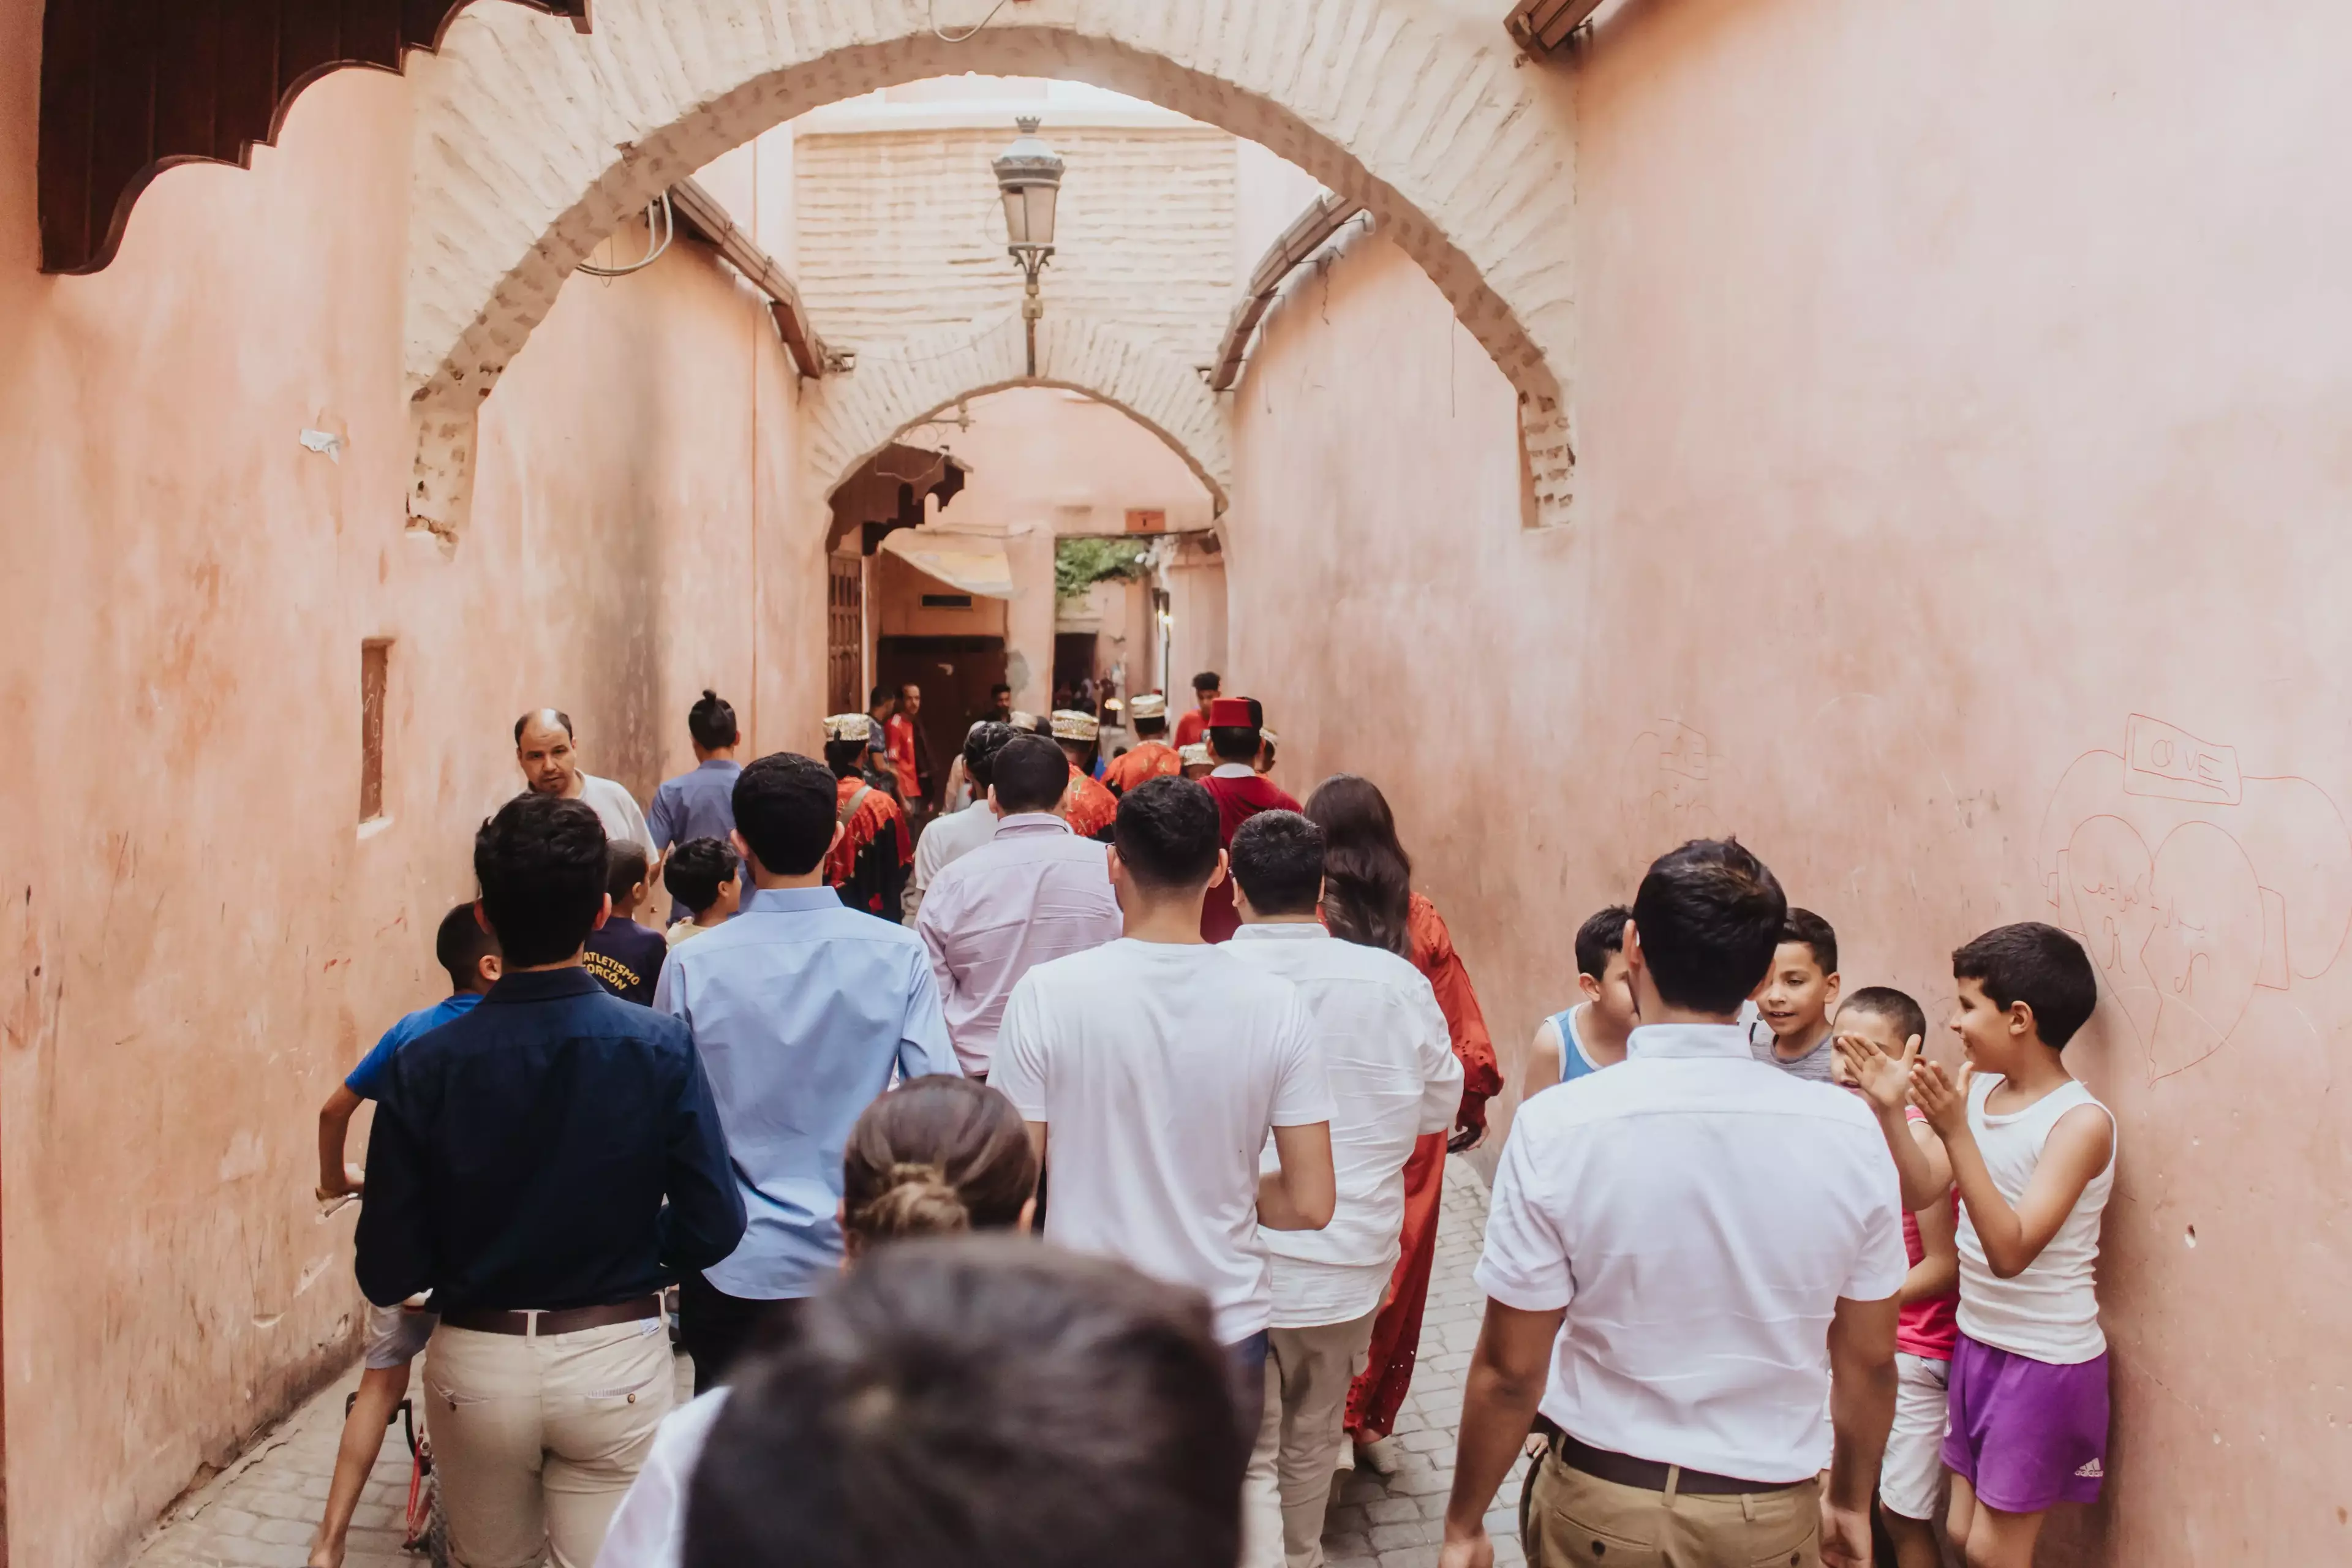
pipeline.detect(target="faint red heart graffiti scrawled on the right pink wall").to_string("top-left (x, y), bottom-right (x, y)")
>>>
top-left (2035, 712), bottom-right (2352, 1084)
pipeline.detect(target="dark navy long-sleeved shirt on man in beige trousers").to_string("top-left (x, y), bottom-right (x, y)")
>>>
top-left (358, 968), bottom-right (743, 1312)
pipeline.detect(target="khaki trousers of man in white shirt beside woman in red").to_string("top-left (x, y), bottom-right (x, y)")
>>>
top-left (1242, 1312), bottom-right (1378, 1568)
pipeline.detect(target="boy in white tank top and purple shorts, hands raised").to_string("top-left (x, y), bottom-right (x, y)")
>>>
top-left (1912, 922), bottom-right (2114, 1568)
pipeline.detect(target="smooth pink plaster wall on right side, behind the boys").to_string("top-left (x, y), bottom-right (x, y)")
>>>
top-left (1230, 0), bottom-right (2352, 1568)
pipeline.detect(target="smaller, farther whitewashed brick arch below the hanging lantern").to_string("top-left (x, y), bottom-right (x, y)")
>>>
top-left (802, 312), bottom-right (1232, 513)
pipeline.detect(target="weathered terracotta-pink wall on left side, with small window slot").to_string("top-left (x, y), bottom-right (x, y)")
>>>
top-left (0, 40), bottom-right (823, 1568)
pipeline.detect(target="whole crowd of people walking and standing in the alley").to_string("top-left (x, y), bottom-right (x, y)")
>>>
top-left (311, 675), bottom-right (2114, 1568)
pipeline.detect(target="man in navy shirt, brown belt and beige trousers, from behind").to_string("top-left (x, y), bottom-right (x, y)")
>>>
top-left (358, 794), bottom-right (743, 1568)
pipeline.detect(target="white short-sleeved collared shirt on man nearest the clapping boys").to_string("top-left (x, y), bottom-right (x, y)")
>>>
top-left (1477, 1025), bottom-right (1907, 1483)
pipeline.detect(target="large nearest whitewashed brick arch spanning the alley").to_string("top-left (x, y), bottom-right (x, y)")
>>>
top-left (407, 0), bottom-right (1576, 529)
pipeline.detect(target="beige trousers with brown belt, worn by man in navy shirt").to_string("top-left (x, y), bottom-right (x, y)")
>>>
top-left (423, 1319), bottom-right (677, 1568)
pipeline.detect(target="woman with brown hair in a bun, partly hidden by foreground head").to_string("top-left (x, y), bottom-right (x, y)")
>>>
top-left (595, 1072), bottom-right (1037, 1568)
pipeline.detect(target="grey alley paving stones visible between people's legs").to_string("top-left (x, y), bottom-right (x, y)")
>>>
top-left (132, 1159), bottom-right (1526, 1568)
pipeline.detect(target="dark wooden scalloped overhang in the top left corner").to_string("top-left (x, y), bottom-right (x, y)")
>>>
top-left (37, 0), bottom-right (588, 273)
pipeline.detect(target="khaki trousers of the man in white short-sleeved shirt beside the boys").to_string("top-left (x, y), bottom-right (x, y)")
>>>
top-left (1521, 1453), bottom-right (1820, 1568)
